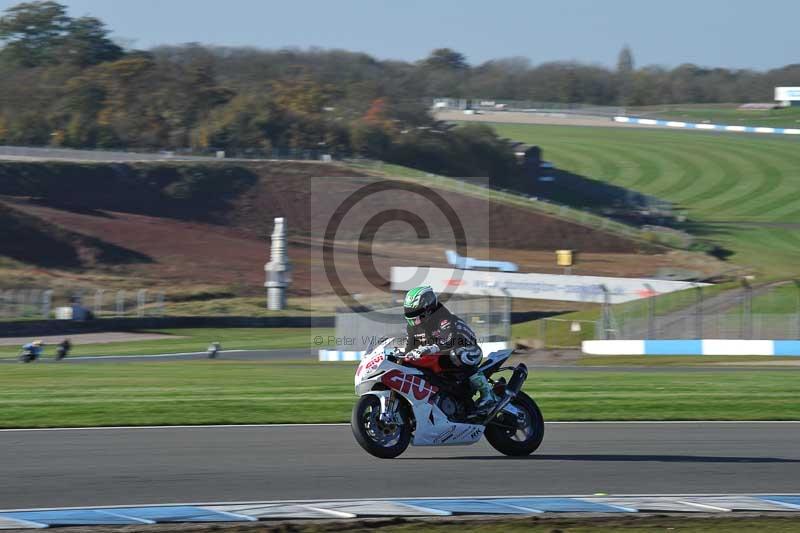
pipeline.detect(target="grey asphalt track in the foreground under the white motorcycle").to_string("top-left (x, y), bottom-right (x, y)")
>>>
top-left (0, 422), bottom-right (800, 509)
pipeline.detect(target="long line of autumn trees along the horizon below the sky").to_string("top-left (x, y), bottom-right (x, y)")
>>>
top-left (0, 0), bottom-right (800, 179)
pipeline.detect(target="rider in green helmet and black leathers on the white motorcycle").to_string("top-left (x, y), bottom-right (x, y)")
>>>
top-left (403, 286), bottom-right (497, 414)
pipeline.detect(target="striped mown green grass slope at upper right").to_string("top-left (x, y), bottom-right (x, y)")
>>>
top-left (482, 124), bottom-right (800, 278)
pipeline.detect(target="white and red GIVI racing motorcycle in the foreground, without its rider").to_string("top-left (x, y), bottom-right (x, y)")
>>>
top-left (350, 338), bottom-right (544, 459)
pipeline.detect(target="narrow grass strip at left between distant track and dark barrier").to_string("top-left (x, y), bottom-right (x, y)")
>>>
top-left (0, 328), bottom-right (333, 358)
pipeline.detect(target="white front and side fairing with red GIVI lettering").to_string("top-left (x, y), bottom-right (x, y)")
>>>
top-left (355, 339), bottom-right (484, 446)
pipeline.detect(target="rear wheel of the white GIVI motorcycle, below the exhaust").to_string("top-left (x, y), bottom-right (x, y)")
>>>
top-left (484, 392), bottom-right (544, 456)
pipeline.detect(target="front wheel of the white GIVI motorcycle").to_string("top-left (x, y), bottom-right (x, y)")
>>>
top-left (350, 394), bottom-right (411, 459)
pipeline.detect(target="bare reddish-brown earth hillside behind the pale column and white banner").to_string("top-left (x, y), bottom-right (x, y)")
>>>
top-left (0, 158), bottom-right (712, 302)
